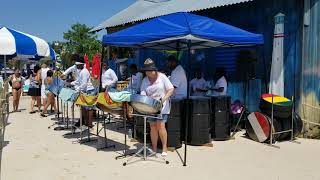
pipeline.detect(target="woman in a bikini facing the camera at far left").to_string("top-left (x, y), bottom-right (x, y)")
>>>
top-left (10, 68), bottom-right (23, 112)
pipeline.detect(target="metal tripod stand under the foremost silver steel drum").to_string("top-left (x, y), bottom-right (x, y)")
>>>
top-left (123, 114), bottom-right (169, 166)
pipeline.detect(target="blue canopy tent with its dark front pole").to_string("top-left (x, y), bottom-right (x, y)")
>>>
top-left (102, 12), bottom-right (264, 166)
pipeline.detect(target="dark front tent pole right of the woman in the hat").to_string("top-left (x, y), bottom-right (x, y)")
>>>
top-left (183, 40), bottom-right (191, 166)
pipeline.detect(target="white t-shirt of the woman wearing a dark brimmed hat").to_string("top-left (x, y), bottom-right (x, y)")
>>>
top-left (141, 73), bottom-right (174, 114)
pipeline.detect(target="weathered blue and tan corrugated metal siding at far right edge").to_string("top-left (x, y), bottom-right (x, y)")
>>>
top-left (300, 0), bottom-right (320, 138)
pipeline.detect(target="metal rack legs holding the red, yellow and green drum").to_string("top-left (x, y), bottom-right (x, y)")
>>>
top-left (267, 93), bottom-right (301, 149)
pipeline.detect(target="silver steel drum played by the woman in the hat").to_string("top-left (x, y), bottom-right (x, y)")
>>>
top-left (130, 94), bottom-right (162, 114)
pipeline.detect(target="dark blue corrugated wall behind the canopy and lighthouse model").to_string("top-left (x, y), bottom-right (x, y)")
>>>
top-left (132, 0), bottom-right (303, 111)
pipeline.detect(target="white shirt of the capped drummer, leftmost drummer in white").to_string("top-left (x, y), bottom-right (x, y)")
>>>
top-left (71, 68), bottom-right (94, 92)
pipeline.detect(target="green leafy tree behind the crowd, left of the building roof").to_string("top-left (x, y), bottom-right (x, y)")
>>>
top-left (62, 23), bottom-right (101, 66)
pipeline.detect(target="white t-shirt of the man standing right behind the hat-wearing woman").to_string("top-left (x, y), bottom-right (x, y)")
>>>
top-left (170, 65), bottom-right (188, 99)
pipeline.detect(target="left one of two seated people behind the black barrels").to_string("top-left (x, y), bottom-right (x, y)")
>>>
top-left (190, 70), bottom-right (207, 96)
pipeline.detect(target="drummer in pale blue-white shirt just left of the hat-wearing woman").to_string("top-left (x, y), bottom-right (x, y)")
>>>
top-left (128, 64), bottom-right (143, 94)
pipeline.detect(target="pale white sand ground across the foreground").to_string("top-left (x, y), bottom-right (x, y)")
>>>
top-left (1, 97), bottom-right (320, 180)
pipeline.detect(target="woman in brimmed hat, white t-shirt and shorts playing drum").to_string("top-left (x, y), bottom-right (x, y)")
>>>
top-left (140, 58), bottom-right (174, 157)
